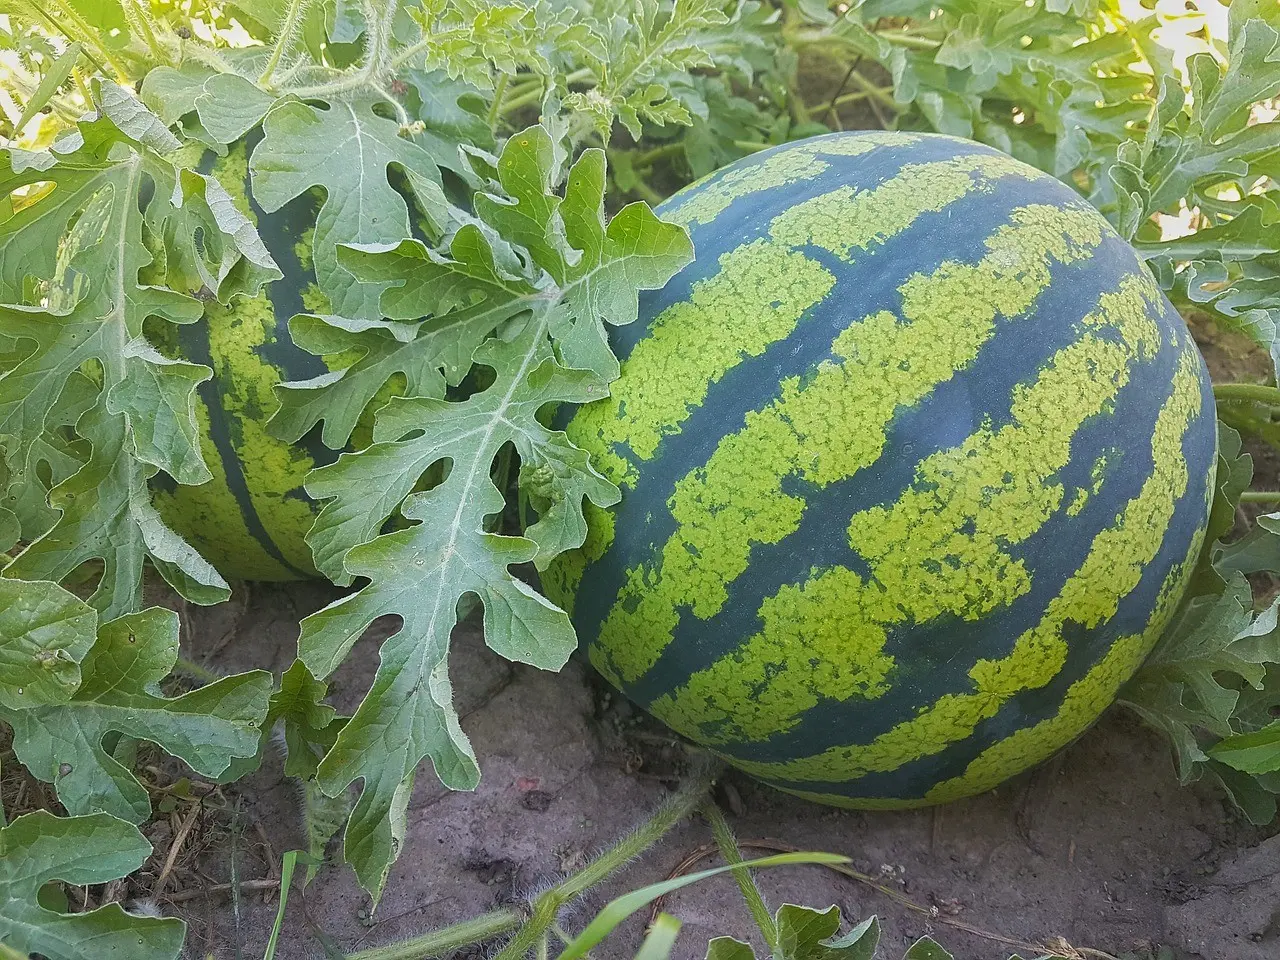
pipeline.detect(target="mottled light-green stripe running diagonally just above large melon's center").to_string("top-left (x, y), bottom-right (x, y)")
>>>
top-left (580, 205), bottom-right (1105, 685)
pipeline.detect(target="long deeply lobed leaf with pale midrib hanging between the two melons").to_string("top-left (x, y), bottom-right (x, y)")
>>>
top-left (294, 127), bottom-right (690, 896)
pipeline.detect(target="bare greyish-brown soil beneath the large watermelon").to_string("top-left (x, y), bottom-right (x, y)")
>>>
top-left (150, 570), bottom-right (1280, 960)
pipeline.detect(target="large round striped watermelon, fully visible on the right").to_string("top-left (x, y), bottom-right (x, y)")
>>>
top-left (544, 132), bottom-right (1216, 806)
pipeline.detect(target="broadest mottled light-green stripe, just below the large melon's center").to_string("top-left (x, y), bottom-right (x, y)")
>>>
top-left (650, 275), bottom-right (1160, 744)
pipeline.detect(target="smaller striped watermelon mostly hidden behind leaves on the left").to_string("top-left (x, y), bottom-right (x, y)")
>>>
top-left (154, 143), bottom-right (337, 580)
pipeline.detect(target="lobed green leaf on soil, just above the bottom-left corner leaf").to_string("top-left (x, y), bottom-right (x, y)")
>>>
top-left (0, 607), bottom-right (270, 823)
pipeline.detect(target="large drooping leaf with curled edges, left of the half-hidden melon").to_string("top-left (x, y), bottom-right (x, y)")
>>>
top-left (0, 81), bottom-right (279, 618)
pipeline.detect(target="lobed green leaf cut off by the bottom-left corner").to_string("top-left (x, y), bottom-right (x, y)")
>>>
top-left (0, 810), bottom-right (187, 960)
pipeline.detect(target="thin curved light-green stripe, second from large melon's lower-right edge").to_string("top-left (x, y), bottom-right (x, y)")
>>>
top-left (732, 348), bottom-right (1202, 782)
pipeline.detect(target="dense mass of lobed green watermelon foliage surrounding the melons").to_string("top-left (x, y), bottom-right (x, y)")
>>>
top-left (0, 0), bottom-right (1280, 956)
